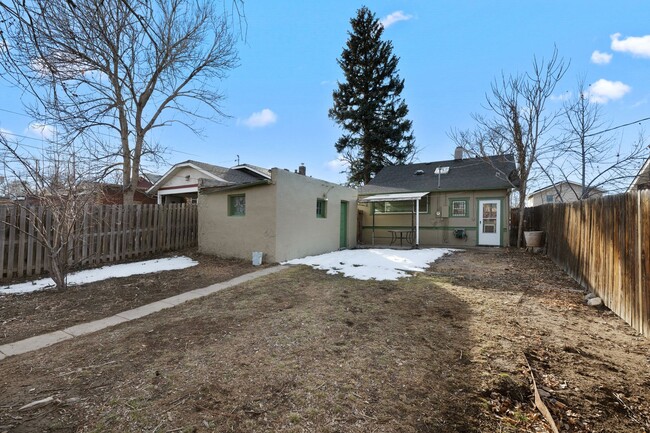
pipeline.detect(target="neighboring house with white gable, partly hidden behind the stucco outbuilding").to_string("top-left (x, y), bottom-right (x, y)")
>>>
top-left (147, 160), bottom-right (271, 204)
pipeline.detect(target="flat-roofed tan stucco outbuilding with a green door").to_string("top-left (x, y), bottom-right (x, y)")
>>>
top-left (198, 166), bottom-right (357, 263)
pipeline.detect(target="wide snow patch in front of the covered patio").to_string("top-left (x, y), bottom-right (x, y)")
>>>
top-left (283, 248), bottom-right (458, 280)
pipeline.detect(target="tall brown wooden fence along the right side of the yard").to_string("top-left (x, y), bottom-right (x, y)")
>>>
top-left (530, 191), bottom-right (650, 337)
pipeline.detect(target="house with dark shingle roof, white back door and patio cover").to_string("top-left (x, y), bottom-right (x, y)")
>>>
top-left (359, 149), bottom-right (517, 247)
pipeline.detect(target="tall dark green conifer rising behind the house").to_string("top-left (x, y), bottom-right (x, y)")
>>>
top-left (329, 6), bottom-right (415, 185)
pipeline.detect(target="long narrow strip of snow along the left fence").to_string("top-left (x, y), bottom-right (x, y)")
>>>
top-left (0, 256), bottom-right (199, 295)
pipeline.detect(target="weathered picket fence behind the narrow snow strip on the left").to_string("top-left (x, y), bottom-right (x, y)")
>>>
top-left (0, 204), bottom-right (198, 279)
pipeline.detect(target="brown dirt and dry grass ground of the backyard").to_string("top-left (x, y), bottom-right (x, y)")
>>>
top-left (0, 249), bottom-right (650, 433)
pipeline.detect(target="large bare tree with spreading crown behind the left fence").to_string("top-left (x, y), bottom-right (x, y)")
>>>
top-left (0, 0), bottom-right (241, 204)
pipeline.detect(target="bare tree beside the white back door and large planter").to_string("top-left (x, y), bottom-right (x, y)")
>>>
top-left (450, 49), bottom-right (568, 247)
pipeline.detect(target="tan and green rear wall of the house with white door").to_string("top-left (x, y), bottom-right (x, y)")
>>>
top-left (359, 190), bottom-right (510, 247)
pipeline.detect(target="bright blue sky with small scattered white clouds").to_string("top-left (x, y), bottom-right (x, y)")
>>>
top-left (0, 0), bottom-right (650, 182)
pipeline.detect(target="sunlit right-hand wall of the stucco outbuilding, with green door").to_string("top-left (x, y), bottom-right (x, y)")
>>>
top-left (272, 169), bottom-right (357, 261)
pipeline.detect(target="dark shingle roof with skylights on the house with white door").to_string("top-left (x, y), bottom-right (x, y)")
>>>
top-left (359, 155), bottom-right (517, 195)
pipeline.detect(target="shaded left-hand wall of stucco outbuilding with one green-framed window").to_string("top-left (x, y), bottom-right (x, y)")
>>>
top-left (198, 181), bottom-right (276, 262)
